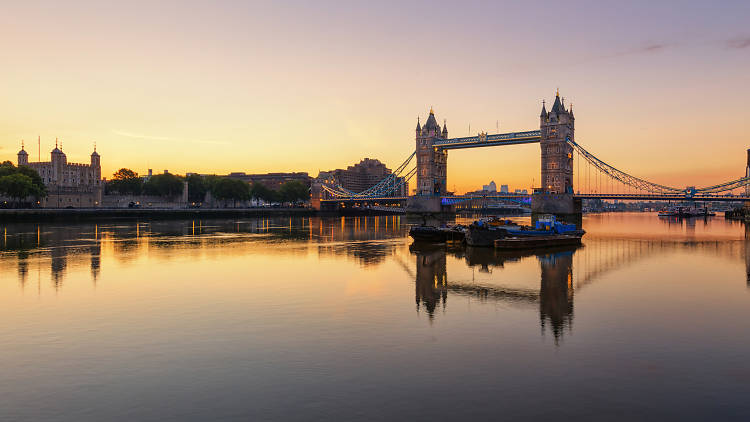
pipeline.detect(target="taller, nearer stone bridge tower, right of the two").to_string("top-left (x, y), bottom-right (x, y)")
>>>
top-left (539, 92), bottom-right (575, 194)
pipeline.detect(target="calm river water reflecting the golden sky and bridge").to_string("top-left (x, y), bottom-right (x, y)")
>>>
top-left (0, 213), bottom-right (750, 421)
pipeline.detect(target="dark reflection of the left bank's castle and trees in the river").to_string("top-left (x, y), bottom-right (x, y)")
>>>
top-left (0, 216), bottom-right (408, 290)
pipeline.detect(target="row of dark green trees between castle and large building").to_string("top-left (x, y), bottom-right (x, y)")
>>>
top-left (106, 168), bottom-right (310, 206)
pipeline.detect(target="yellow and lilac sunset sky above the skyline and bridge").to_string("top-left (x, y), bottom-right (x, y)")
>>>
top-left (0, 0), bottom-right (750, 192)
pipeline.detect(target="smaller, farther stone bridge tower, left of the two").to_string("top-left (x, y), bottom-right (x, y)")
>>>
top-left (416, 108), bottom-right (448, 196)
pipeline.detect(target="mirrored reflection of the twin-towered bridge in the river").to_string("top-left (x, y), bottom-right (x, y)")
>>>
top-left (412, 238), bottom-right (750, 339)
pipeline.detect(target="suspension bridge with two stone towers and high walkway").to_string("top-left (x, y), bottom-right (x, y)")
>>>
top-left (313, 90), bottom-right (750, 215)
